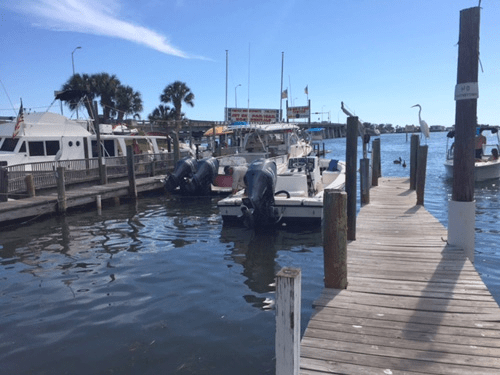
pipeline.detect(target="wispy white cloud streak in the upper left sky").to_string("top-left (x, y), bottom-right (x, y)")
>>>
top-left (16, 0), bottom-right (199, 59)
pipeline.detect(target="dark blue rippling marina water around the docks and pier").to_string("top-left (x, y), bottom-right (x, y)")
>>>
top-left (0, 133), bottom-right (500, 375)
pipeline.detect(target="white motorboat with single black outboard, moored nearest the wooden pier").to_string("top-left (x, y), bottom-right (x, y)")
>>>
top-left (217, 156), bottom-right (345, 227)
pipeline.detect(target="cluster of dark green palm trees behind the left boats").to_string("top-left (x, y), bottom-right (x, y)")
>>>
top-left (61, 73), bottom-right (194, 128)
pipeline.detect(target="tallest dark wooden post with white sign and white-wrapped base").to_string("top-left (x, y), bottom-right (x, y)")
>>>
top-left (448, 7), bottom-right (480, 262)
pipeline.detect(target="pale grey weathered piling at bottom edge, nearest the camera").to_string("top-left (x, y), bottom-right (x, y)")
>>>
top-left (275, 268), bottom-right (302, 375)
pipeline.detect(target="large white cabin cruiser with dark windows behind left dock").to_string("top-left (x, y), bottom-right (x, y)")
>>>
top-left (0, 112), bottom-right (174, 168)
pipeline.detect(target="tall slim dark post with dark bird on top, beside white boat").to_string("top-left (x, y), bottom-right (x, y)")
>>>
top-left (345, 116), bottom-right (358, 240)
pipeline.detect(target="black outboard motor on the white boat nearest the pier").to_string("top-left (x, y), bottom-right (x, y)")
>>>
top-left (241, 159), bottom-right (277, 228)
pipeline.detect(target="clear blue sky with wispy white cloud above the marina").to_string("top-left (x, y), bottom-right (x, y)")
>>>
top-left (0, 0), bottom-right (500, 126)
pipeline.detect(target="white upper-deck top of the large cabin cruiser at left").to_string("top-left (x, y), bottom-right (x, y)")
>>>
top-left (0, 112), bottom-right (91, 137)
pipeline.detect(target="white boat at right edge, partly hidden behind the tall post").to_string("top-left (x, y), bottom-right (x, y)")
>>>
top-left (444, 126), bottom-right (500, 182)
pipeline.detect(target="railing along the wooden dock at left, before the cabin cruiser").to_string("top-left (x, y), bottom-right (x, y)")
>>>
top-left (7, 152), bottom-right (189, 197)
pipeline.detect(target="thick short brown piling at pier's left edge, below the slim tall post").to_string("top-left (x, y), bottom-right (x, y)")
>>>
top-left (323, 189), bottom-right (348, 289)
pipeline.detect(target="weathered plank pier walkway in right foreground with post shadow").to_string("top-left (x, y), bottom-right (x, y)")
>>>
top-left (300, 178), bottom-right (500, 375)
